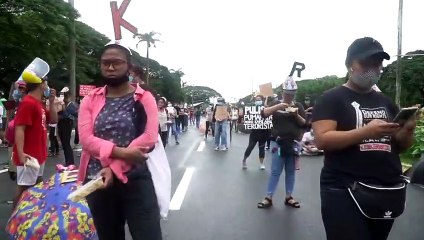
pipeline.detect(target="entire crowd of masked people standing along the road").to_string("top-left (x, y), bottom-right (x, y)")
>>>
top-left (0, 38), bottom-right (416, 240)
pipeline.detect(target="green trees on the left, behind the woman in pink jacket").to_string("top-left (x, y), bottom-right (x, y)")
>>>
top-left (0, 0), bottom-right (184, 101)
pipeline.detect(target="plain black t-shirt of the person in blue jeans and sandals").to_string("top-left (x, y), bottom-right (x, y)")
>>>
top-left (268, 101), bottom-right (305, 140)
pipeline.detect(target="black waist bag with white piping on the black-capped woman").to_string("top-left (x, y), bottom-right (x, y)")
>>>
top-left (348, 182), bottom-right (406, 219)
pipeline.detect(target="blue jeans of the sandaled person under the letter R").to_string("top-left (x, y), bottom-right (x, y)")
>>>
top-left (267, 141), bottom-right (296, 198)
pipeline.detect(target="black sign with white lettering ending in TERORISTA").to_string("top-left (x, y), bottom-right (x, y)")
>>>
top-left (243, 106), bottom-right (272, 130)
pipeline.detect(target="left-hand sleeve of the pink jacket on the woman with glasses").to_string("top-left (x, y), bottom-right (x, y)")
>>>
top-left (78, 95), bottom-right (115, 167)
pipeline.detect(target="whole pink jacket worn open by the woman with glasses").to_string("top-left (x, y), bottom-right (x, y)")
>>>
top-left (78, 85), bottom-right (159, 183)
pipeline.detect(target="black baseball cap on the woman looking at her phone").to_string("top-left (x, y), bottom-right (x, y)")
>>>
top-left (345, 37), bottom-right (390, 67)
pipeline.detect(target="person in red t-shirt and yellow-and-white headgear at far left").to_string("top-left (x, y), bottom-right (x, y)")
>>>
top-left (13, 76), bottom-right (57, 208)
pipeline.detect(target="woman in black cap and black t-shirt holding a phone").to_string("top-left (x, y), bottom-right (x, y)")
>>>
top-left (312, 37), bottom-right (416, 240)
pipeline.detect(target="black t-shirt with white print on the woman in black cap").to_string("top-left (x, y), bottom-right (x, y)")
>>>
top-left (312, 86), bottom-right (402, 186)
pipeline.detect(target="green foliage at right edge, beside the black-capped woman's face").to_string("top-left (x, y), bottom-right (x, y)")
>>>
top-left (378, 50), bottom-right (424, 106)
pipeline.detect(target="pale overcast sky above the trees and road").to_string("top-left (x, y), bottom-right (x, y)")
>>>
top-left (75, 0), bottom-right (424, 100)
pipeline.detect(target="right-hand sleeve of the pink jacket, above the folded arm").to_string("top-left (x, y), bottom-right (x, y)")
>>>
top-left (128, 91), bottom-right (159, 147)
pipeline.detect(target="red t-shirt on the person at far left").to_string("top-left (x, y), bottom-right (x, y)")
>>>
top-left (13, 95), bottom-right (49, 166)
